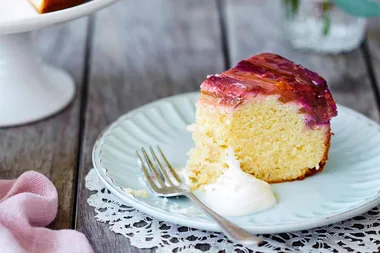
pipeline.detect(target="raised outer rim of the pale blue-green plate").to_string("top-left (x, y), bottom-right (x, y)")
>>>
top-left (92, 91), bottom-right (380, 234)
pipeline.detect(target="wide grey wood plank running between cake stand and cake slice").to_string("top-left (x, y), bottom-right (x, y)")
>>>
top-left (77, 0), bottom-right (224, 252)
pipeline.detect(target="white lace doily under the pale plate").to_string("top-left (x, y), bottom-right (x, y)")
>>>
top-left (86, 169), bottom-right (380, 253)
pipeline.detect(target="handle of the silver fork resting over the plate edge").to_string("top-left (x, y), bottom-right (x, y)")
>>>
top-left (185, 192), bottom-right (263, 245)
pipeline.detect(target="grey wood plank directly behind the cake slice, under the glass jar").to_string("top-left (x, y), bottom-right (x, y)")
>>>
top-left (225, 0), bottom-right (379, 121)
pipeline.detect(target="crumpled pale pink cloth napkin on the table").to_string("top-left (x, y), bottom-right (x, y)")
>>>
top-left (0, 171), bottom-right (93, 253)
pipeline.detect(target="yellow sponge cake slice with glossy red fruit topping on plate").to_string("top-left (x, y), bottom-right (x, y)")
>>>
top-left (186, 53), bottom-right (337, 189)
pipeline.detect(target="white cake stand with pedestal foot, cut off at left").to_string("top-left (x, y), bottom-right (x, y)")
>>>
top-left (0, 0), bottom-right (117, 127)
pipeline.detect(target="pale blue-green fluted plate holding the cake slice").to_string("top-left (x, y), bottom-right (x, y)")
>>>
top-left (93, 93), bottom-right (380, 233)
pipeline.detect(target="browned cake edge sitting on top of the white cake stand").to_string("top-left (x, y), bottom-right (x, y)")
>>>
top-left (30, 0), bottom-right (88, 14)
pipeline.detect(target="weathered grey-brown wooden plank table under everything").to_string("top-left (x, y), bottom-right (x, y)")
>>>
top-left (0, 0), bottom-right (380, 252)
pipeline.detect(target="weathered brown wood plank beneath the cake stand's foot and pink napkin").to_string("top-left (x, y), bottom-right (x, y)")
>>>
top-left (0, 19), bottom-right (87, 229)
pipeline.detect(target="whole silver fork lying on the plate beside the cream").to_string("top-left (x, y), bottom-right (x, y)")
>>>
top-left (136, 146), bottom-right (263, 245)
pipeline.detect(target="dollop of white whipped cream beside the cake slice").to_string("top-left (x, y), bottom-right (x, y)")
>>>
top-left (201, 147), bottom-right (277, 216)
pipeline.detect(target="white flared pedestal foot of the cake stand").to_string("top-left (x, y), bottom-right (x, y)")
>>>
top-left (0, 32), bottom-right (75, 127)
